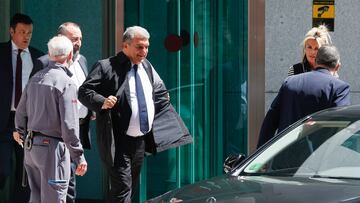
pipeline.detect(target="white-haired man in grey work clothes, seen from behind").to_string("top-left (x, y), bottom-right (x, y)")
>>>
top-left (15, 36), bottom-right (87, 203)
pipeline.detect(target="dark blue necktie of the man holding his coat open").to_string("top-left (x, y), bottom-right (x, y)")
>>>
top-left (133, 64), bottom-right (149, 134)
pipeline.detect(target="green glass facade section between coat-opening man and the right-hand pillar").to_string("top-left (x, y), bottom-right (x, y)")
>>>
top-left (124, 0), bottom-right (247, 202)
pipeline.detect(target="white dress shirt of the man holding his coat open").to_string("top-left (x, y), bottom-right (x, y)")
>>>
top-left (126, 64), bottom-right (155, 137)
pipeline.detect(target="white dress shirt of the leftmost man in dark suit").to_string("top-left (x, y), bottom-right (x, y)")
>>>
top-left (11, 41), bottom-right (34, 111)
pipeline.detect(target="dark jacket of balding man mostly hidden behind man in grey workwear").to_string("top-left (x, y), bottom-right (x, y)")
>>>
top-left (37, 54), bottom-right (92, 149)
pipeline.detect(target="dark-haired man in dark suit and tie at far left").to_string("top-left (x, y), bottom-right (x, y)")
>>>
top-left (0, 13), bottom-right (43, 202)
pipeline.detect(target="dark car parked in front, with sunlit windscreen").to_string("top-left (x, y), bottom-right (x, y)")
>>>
top-left (148, 105), bottom-right (360, 203)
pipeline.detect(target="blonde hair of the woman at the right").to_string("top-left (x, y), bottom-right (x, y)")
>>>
top-left (301, 25), bottom-right (332, 58)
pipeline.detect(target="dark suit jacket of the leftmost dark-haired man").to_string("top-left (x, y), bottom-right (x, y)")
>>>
top-left (0, 41), bottom-right (44, 140)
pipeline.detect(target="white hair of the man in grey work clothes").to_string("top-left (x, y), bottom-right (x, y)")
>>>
top-left (47, 35), bottom-right (73, 59)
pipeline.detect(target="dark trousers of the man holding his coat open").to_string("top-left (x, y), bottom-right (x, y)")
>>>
top-left (108, 135), bottom-right (145, 203)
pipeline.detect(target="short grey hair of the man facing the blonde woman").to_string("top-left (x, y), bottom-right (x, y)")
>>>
top-left (315, 45), bottom-right (340, 69)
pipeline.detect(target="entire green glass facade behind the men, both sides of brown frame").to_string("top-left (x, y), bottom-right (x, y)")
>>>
top-left (0, 0), bottom-right (248, 202)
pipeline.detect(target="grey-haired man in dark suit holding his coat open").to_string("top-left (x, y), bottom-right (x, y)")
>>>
top-left (79, 26), bottom-right (192, 203)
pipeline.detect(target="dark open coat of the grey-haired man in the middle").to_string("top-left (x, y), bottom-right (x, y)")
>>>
top-left (79, 52), bottom-right (192, 166)
